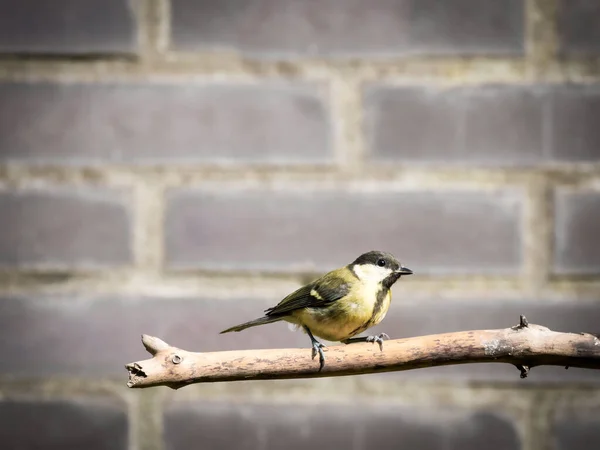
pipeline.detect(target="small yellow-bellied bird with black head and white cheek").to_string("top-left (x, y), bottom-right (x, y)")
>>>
top-left (221, 250), bottom-right (413, 371)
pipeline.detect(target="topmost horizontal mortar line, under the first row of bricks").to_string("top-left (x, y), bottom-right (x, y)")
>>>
top-left (0, 55), bottom-right (600, 86)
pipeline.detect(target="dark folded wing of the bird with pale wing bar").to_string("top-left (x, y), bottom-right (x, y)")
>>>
top-left (265, 277), bottom-right (350, 316)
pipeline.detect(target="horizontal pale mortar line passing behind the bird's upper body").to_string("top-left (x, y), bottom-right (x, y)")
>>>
top-left (0, 272), bottom-right (600, 303)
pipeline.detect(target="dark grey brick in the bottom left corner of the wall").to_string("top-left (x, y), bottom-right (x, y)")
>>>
top-left (0, 399), bottom-right (129, 450)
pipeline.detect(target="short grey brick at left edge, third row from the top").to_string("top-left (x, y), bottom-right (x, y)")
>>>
top-left (0, 188), bottom-right (132, 269)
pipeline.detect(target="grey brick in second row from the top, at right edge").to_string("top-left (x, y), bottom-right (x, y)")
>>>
top-left (365, 85), bottom-right (600, 166)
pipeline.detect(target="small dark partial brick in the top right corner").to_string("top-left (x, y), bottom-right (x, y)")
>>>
top-left (557, 0), bottom-right (600, 55)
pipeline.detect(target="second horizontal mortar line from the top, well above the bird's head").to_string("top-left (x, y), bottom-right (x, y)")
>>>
top-left (5, 163), bottom-right (600, 189)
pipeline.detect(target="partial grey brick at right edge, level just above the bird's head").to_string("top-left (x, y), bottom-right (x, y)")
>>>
top-left (554, 190), bottom-right (600, 274)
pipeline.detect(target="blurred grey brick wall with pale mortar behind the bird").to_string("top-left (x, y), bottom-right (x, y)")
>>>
top-left (0, 0), bottom-right (600, 450)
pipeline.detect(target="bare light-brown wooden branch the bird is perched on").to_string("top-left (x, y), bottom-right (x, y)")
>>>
top-left (125, 316), bottom-right (600, 389)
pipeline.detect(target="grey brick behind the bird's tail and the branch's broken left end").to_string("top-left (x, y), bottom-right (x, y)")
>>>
top-left (0, 295), bottom-right (309, 378)
